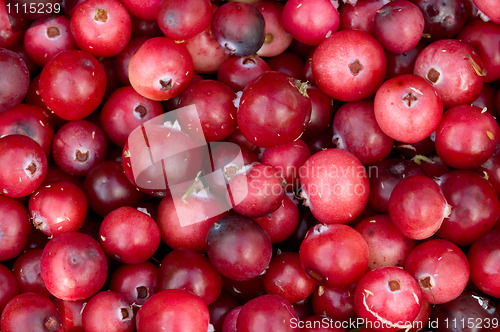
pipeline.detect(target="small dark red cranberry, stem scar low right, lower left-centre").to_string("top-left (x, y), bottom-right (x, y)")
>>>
top-left (109, 262), bottom-right (158, 305)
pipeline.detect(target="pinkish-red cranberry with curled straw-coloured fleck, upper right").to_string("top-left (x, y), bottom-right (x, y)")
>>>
top-left (413, 39), bottom-right (484, 109)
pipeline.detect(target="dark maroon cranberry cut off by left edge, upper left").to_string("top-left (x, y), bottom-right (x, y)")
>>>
top-left (0, 48), bottom-right (30, 113)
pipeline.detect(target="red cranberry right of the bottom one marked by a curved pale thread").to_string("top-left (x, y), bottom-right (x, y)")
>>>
top-left (405, 239), bottom-right (470, 304)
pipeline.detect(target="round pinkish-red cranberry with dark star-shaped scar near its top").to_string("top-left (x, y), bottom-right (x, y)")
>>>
top-left (374, 75), bottom-right (443, 143)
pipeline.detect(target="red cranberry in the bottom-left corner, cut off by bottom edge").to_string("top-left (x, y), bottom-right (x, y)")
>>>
top-left (0, 292), bottom-right (65, 332)
